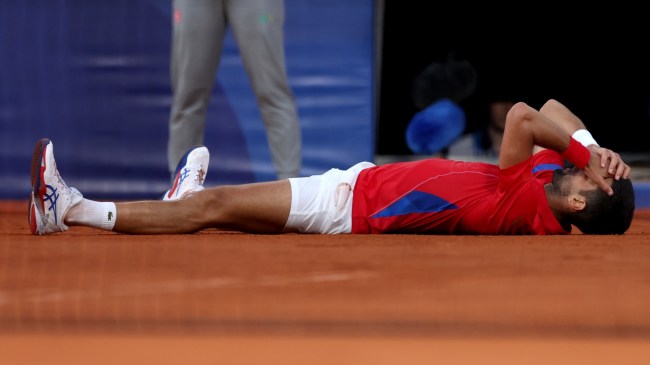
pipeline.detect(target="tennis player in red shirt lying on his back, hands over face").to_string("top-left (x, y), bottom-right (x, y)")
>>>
top-left (28, 100), bottom-right (634, 235)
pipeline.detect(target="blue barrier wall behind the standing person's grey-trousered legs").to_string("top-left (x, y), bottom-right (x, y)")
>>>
top-left (0, 0), bottom-right (374, 199)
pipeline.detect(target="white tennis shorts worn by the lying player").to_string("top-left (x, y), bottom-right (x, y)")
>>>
top-left (283, 162), bottom-right (375, 234)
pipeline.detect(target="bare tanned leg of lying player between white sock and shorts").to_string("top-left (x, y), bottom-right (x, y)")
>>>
top-left (66, 180), bottom-right (291, 234)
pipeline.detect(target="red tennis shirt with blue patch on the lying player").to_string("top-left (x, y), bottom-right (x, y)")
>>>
top-left (352, 150), bottom-right (571, 235)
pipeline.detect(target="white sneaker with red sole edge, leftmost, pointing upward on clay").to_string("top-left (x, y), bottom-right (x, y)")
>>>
top-left (27, 138), bottom-right (83, 235)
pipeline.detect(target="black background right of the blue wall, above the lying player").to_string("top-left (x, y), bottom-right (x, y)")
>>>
top-left (377, 1), bottom-right (650, 155)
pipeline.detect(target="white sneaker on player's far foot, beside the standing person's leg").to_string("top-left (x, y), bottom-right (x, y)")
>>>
top-left (163, 146), bottom-right (210, 200)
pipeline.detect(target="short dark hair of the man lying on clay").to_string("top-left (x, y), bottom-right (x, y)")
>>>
top-left (571, 179), bottom-right (634, 234)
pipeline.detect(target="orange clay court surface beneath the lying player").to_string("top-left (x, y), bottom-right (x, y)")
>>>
top-left (0, 201), bottom-right (650, 365)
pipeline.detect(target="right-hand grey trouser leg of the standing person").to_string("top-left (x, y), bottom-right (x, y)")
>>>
top-left (226, 0), bottom-right (302, 179)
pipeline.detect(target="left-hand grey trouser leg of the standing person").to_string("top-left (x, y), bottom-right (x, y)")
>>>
top-left (167, 0), bottom-right (227, 178)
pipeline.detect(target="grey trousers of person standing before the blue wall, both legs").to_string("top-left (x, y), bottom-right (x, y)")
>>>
top-left (167, 0), bottom-right (302, 179)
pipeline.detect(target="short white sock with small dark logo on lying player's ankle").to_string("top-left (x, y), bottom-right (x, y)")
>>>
top-left (65, 199), bottom-right (117, 231)
